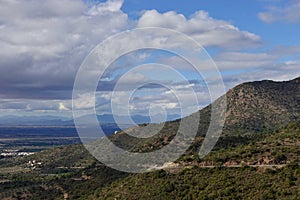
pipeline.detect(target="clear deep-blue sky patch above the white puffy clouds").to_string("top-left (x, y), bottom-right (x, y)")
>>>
top-left (122, 0), bottom-right (300, 45)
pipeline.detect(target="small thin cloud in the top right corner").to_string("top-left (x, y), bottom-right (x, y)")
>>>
top-left (258, 0), bottom-right (300, 23)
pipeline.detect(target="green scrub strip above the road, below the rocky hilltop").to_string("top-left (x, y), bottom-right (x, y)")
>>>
top-left (179, 121), bottom-right (300, 165)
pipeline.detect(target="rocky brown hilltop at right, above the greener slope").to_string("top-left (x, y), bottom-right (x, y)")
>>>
top-left (224, 77), bottom-right (300, 134)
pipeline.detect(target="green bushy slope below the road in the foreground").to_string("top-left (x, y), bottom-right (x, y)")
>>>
top-left (95, 165), bottom-right (300, 200)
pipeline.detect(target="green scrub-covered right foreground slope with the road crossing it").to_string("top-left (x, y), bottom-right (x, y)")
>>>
top-left (94, 121), bottom-right (300, 199)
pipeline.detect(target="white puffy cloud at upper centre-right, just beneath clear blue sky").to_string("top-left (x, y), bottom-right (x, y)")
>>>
top-left (138, 10), bottom-right (260, 48)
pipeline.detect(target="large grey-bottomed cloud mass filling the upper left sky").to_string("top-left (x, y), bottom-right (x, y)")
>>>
top-left (0, 0), bottom-right (128, 99)
